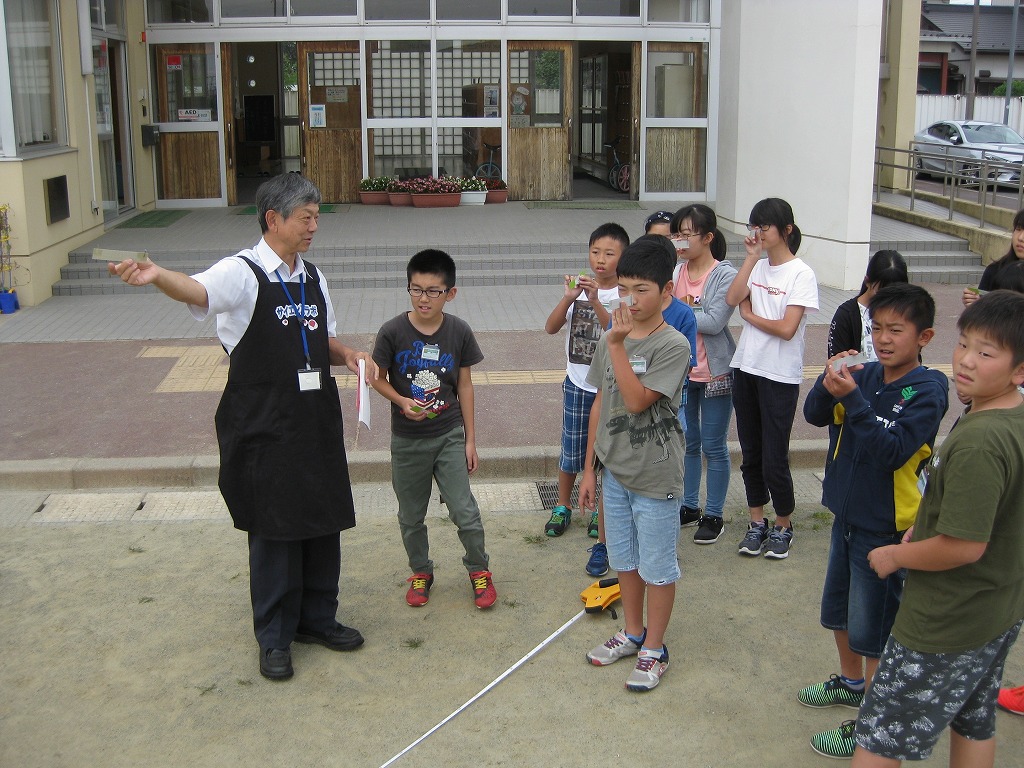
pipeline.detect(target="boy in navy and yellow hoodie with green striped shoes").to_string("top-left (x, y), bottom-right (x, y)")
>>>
top-left (797, 283), bottom-right (949, 758)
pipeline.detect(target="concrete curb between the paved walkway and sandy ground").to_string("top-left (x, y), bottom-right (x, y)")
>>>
top-left (0, 439), bottom-right (828, 490)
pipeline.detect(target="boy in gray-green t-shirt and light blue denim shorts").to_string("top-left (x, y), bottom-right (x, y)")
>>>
top-left (580, 238), bottom-right (690, 691)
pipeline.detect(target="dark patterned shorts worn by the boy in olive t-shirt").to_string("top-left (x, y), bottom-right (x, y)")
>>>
top-left (855, 622), bottom-right (1021, 760)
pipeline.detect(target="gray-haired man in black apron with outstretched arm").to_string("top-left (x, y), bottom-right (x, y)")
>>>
top-left (108, 173), bottom-right (377, 680)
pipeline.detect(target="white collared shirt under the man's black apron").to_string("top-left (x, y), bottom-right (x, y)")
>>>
top-left (188, 239), bottom-right (337, 354)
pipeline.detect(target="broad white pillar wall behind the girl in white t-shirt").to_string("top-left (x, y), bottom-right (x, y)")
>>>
top-left (717, 0), bottom-right (882, 290)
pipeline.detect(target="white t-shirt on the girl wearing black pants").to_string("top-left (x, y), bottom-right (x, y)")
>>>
top-left (732, 258), bottom-right (818, 384)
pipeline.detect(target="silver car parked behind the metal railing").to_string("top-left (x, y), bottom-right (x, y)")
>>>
top-left (912, 120), bottom-right (1024, 186)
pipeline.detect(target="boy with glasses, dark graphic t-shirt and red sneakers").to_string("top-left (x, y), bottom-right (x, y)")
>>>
top-left (373, 250), bottom-right (498, 608)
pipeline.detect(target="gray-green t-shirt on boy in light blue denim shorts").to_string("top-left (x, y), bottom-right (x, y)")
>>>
top-left (587, 327), bottom-right (690, 499)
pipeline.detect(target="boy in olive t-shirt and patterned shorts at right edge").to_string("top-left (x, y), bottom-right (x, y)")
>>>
top-left (853, 291), bottom-right (1024, 768)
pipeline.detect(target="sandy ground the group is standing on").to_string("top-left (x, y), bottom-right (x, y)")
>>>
top-left (0, 483), bottom-right (1024, 768)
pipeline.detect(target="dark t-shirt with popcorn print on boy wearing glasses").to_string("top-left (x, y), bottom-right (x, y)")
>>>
top-left (374, 312), bottom-right (483, 437)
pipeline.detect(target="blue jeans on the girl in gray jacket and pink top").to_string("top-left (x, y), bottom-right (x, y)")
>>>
top-left (683, 381), bottom-right (732, 517)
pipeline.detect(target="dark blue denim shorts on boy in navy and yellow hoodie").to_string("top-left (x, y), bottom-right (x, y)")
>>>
top-left (821, 522), bottom-right (906, 658)
